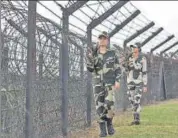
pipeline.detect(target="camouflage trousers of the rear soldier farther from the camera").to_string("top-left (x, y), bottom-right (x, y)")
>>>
top-left (127, 84), bottom-right (143, 113)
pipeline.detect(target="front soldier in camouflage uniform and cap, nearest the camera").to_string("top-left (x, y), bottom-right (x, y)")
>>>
top-left (87, 31), bottom-right (121, 137)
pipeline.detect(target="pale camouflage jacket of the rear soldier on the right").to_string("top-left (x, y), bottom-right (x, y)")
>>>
top-left (127, 54), bottom-right (147, 86)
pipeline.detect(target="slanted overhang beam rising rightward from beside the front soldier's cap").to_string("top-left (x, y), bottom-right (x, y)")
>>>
top-left (109, 10), bottom-right (140, 37)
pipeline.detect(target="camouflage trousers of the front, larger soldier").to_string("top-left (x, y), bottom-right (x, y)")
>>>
top-left (94, 85), bottom-right (115, 122)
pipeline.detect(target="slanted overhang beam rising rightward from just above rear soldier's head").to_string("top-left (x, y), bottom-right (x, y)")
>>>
top-left (124, 22), bottom-right (155, 46)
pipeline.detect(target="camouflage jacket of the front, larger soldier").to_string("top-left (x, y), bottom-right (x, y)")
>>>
top-left (87, 49), bottom-right (121, 86)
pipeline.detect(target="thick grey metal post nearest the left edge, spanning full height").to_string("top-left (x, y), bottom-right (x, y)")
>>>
top-left (25, 1), bottom-right (37, 138)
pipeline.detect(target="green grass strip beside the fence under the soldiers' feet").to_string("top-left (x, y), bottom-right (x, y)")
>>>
top-left (70, 100), bottom-right (178, 138)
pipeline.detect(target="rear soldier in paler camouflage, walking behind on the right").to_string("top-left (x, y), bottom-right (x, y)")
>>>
top-left (127, 43), bottom-right (147, 125)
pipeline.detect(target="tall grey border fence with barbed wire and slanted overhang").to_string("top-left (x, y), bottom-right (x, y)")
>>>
top-left (0, 1), bottom-right (178, 138)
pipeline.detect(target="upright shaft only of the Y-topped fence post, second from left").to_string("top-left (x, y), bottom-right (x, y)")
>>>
top-left (60, 10), bottom-right (69, 136)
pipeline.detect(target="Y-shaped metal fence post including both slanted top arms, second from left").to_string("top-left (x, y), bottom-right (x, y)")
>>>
top-left (55, 1), bottom-right (87, 136)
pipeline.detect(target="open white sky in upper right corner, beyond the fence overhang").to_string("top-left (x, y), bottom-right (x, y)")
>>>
top-left (132, 1), bottom-right (178, 37)
